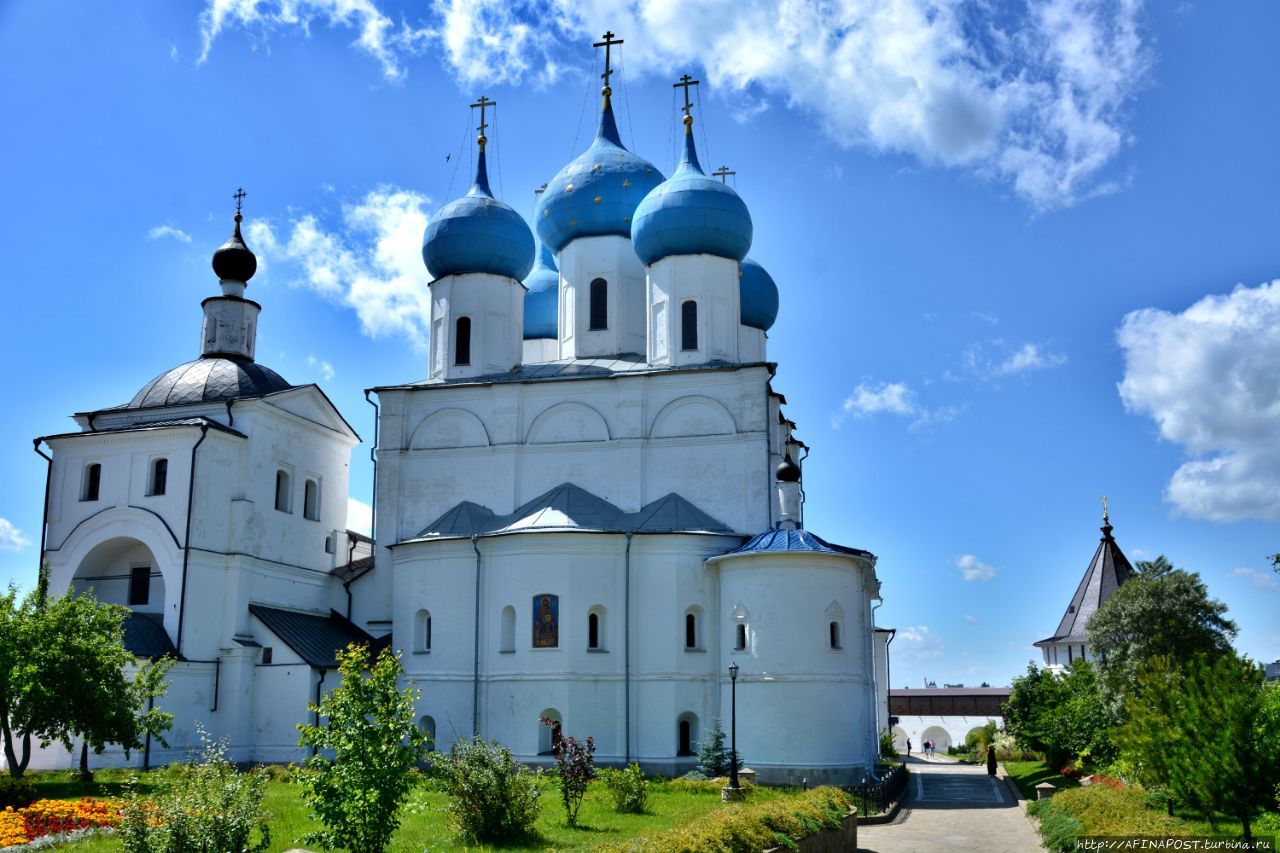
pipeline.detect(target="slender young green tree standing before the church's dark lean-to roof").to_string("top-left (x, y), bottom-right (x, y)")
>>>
top-left (298, 644), bottom-right (429, 853)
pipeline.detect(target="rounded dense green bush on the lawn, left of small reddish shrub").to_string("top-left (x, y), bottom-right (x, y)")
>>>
top-left (436, 738), bottom-right (541, 844)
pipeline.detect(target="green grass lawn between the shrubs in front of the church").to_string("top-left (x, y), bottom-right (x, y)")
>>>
top-left (29, 771), bottom-right (800, 853)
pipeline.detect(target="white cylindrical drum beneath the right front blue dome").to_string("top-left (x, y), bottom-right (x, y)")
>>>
top-left (645, 255), bottom-right (741, 366)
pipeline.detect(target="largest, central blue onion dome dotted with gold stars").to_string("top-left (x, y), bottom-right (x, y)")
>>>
top-left (536, 92), bottom-right (662, 252)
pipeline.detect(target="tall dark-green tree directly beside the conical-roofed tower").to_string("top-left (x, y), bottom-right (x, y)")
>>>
top-left (1088, 556), bottom-right (1235, 724)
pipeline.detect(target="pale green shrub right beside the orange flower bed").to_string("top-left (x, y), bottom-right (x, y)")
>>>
top-left (118, 731), bottom-right (271, 853)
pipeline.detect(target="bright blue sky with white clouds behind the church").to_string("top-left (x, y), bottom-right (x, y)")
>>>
top-left (0, 0), bottom-right (1280, 686)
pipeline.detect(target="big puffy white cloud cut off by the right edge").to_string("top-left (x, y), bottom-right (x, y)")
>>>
top-left (1116, 279), bottom-right (1280, 521)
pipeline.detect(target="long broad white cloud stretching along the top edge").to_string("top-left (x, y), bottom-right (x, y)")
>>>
top-left (200, 0), bottom-right (1153, 210)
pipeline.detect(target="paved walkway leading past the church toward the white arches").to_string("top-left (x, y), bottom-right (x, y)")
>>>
top-left (858, 756), bottom-right (1042, 853)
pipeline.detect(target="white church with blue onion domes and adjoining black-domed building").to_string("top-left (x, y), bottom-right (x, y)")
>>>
top-left (36, 51), bottom-right (891, 784)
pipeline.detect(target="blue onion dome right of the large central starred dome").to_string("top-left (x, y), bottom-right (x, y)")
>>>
top-left (631, 117), bottom-right (751, 266)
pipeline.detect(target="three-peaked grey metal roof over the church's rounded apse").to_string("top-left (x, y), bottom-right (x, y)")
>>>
top-left (417, 483), bottom-right (732, 538)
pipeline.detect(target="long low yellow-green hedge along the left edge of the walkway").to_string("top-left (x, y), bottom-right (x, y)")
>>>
top-left (600, 788), bottom-right (852, 853)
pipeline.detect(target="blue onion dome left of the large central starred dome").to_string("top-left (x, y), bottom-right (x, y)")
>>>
top-left (422, 144), bottom-right (534, 282)
